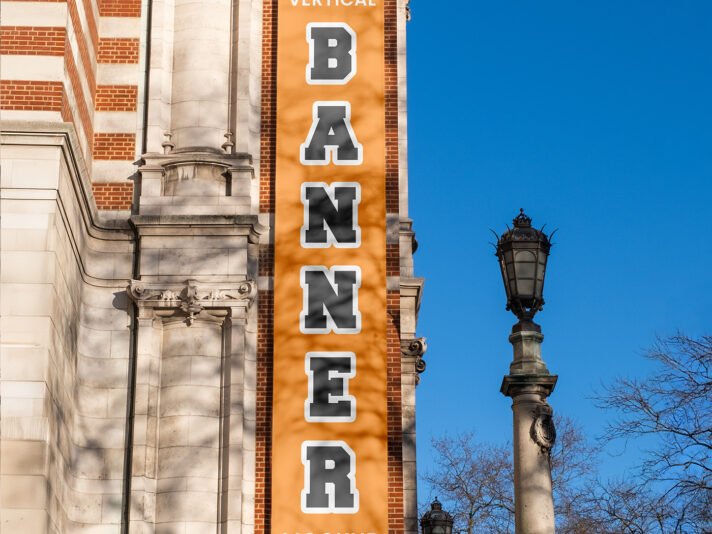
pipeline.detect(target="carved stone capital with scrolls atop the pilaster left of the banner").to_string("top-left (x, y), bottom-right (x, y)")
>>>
top-left (126, 280), bottom-right (256, 326)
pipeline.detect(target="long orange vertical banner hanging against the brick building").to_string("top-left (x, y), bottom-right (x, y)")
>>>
top-left (271, 0), bottom-right (388, 534)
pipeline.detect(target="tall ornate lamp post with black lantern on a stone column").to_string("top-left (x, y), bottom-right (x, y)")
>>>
top-left (497, 210), bottom-right (558, 534)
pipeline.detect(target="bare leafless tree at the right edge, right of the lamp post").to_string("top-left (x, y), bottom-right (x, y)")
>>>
top-left (597, 334), bottom-right (712, 532)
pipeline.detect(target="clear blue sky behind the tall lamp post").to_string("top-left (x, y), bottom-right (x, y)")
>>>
top-left (408, 0), bottom-right (712, 499)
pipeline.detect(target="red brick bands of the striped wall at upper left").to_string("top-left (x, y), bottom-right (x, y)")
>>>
top-left (0, 0), bottom-right (141, 209)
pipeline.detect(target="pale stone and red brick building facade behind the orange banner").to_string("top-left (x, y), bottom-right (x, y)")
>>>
top-left (0, 0), bottom-right (425, 534)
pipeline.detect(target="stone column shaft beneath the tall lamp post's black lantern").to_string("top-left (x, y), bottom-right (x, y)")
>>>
top-left (501, 322), bottom-right (557, 534)
